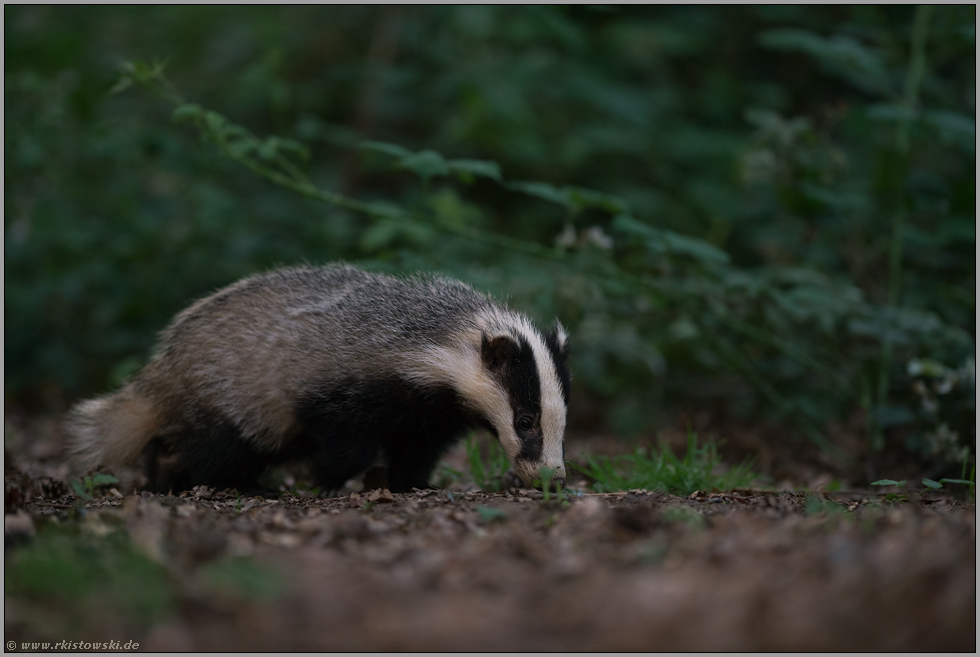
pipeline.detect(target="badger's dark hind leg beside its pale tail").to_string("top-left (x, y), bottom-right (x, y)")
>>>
top-left (144, 414), bottom-right (279, 492)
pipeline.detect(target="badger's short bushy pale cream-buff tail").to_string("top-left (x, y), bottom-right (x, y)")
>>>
top-left (65, 385), bottom-right (159, 473)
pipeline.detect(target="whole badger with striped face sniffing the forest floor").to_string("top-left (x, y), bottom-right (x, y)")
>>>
top-left (66, 263), bottom-right (570, 492)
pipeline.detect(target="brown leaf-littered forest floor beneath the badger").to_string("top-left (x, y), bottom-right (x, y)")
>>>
top-left (4, 416), bottom-right (976, 652)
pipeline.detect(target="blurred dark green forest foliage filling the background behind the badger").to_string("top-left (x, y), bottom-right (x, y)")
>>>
top-left (4, 6), bottom-right (976, 468)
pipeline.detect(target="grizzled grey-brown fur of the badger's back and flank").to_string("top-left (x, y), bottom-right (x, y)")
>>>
top-left (145, 266), bottom-right (492, 438)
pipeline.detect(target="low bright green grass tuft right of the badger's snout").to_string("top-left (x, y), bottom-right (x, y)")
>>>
top-left (574, 431), bottom-right (758, 495)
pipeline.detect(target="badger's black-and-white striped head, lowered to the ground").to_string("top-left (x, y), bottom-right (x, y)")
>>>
top-left (480, 321), bottom-right (571, 488)
